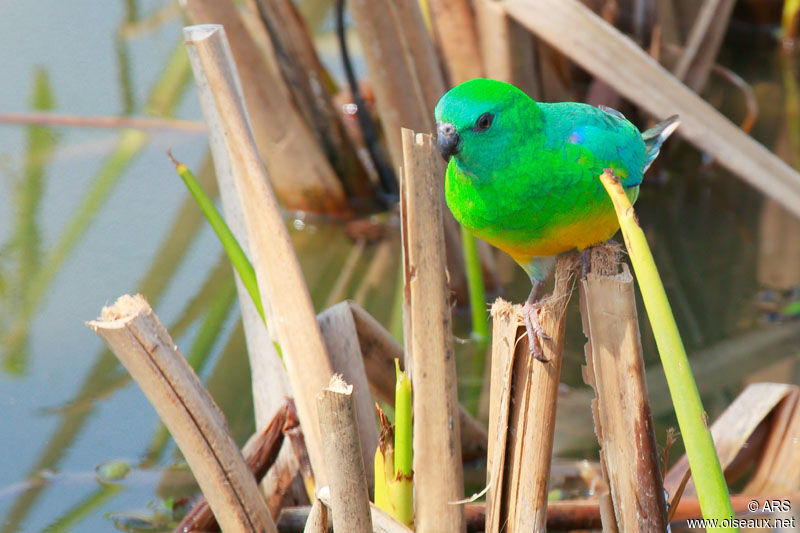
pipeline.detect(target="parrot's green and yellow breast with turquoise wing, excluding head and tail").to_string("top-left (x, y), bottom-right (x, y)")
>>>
top-left (445, 104), bottom-right (645, 255)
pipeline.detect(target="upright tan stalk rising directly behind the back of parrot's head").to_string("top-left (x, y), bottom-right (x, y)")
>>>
top-left (474, 0), bottom-right (541, 95)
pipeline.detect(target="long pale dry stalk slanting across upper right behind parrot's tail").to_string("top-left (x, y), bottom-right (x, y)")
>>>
top-left (504, 0), bottom-right (800, 215)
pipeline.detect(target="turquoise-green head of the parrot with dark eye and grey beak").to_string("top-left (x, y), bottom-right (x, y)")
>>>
top-left (434, 78), bottom-right (542, 177)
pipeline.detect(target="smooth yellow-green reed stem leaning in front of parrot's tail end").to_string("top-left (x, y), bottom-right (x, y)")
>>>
top-left (600, 169), bottom-right (736, 529)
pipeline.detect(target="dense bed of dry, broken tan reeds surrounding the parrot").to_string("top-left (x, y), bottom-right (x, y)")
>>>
top-left (75, 0), bottom-right (800, 532)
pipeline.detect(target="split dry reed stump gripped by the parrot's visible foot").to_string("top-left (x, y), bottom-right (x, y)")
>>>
top-left (486, 254), bottom-right (577, 532)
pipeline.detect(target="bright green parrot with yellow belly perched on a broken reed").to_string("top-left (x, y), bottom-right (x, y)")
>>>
top-left (435, 78), bottom-right (679, 360)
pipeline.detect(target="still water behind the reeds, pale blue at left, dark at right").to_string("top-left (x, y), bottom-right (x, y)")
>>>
top-left (0, 0), bottom-right (800, 531)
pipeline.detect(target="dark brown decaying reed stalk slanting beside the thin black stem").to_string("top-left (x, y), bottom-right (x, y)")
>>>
top-left (251, 0), bottom-right (375, 205)
